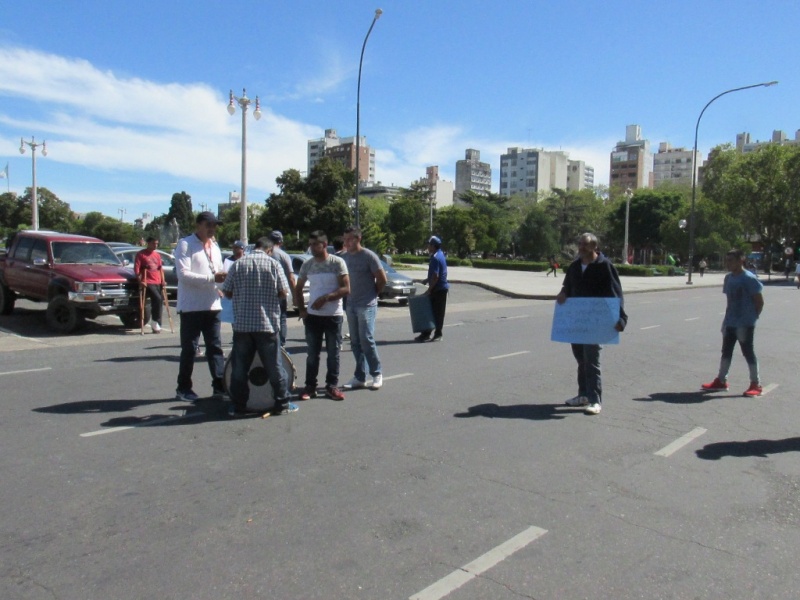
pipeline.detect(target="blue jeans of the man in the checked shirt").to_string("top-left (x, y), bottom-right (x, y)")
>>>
top-left (230, 331), bottom-right (289, 410)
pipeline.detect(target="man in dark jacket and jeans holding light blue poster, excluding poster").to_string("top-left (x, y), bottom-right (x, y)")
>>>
top-left (556, 233), bottom-right (628, 415)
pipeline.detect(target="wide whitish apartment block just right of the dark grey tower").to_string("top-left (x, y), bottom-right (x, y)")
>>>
top-left (500, 148), bottom-right (594, 196)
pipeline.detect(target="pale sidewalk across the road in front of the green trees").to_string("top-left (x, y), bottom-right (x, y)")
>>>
top-left (399, 267), bottom-right (728, 300)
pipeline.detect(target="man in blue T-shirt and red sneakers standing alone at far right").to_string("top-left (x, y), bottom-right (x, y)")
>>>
top-left (700, 250), bottom-right (764, 397)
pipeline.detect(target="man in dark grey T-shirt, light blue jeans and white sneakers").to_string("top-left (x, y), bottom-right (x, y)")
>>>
top-left (342, 227), bottom-right (386, 390)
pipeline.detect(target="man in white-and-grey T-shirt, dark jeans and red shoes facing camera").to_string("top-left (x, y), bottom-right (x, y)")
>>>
top-left (294, 231), bottom-right (350, 400)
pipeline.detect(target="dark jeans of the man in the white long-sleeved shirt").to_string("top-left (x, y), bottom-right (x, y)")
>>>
top-left (178, 310), bottom-right (225, 392)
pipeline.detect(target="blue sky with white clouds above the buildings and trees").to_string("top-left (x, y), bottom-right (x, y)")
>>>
top-left (0, 0), bottom-right (800, 221)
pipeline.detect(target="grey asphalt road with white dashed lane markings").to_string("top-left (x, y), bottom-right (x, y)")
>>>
top-left (0, 285), bottom-right (800, 600)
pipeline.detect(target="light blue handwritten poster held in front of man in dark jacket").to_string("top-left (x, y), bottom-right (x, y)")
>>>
top-left (550, 298), bottom-right (619, 344)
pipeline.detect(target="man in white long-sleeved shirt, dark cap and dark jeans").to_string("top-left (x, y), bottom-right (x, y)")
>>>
top-left (175, 211), bottom-right (225, 402)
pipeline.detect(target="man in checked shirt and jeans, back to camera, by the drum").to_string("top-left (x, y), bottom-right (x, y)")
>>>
top-left (222, 237), bottom-right (297, 417)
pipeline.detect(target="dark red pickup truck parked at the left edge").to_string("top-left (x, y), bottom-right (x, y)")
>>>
top-left (0, 231), bottom-right (150, 333)
